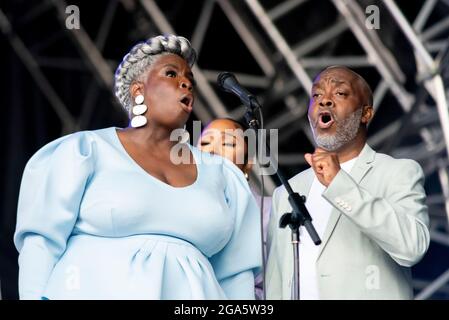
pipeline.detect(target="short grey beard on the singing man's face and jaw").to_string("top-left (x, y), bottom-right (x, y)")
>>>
top-left (311, 108), bottom-right (363, 151)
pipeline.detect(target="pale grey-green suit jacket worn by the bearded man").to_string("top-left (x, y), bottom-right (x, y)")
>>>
top-left (266, 145), bottom-right (430, 299)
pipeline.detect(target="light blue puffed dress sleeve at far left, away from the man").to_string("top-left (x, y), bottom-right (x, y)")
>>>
top-left (14, 132), bottom-right (94, 299)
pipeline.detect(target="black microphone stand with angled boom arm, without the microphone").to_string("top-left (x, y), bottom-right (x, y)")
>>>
top-left (241, 95), bottom-right (321, 300)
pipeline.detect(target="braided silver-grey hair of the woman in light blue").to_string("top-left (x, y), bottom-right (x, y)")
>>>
top-left (114, 35), bottom-right (196, 114)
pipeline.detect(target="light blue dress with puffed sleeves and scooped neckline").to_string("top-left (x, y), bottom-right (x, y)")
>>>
top-left (14, 127), bottom-right (261, 299)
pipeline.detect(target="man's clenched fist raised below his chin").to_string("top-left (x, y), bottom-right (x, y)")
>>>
top-left (304, 148), bottom-right (340, 187)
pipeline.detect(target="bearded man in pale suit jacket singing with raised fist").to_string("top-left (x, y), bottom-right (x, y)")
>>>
top-left (266, 66), bottom-right (429, 299)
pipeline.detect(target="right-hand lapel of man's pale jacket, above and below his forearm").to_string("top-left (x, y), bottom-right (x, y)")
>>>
top-left (309, 144), bottom-right (376, 260)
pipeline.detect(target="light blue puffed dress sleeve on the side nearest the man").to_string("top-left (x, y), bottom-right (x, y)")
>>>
top-left (207, 159), bottom-right (262, 300)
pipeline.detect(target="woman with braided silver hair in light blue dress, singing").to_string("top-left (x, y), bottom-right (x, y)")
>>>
top-left (14, 35), bottom-right (261, 299)
